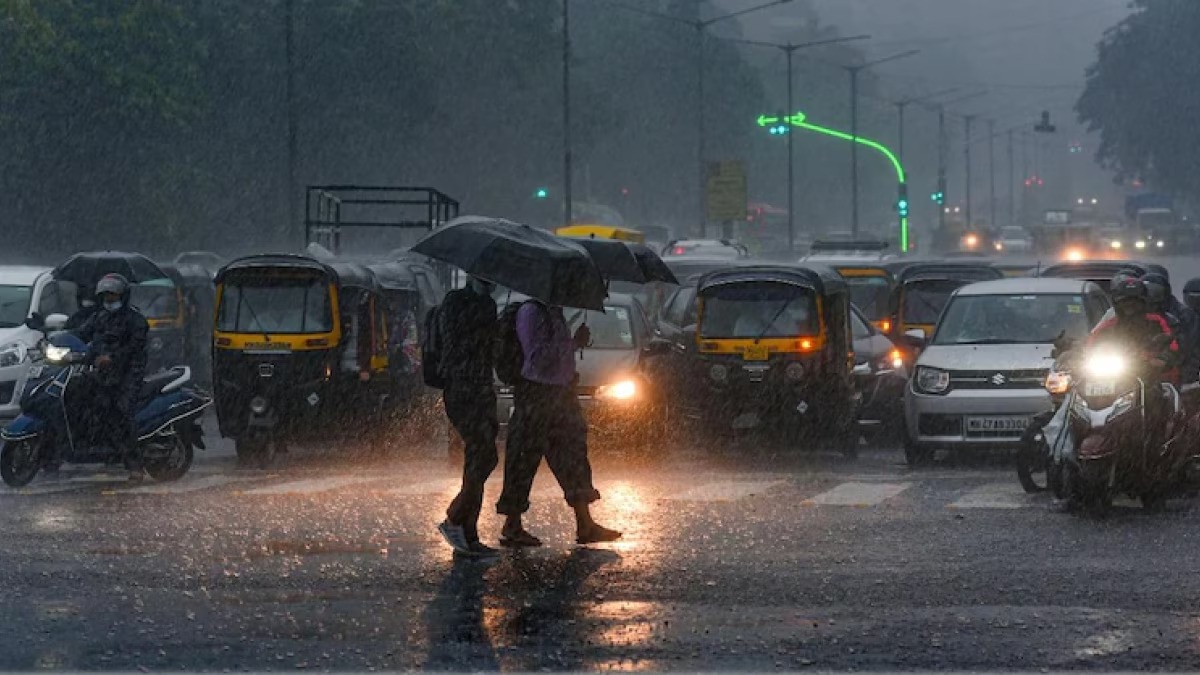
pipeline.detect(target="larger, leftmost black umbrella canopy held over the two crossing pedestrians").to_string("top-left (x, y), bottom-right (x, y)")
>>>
top-left (412, 216), bottom-right (607, 311)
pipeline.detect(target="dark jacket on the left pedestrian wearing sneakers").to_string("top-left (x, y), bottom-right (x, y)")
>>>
top-left (438, 288), bottom-right (499, 386)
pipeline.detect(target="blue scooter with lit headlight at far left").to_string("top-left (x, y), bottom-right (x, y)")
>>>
top-left (0, 315), bottom-right (212, 488)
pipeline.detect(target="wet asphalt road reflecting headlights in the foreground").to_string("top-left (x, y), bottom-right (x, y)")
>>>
top-left (0, 427), bottom-right (1200, 670)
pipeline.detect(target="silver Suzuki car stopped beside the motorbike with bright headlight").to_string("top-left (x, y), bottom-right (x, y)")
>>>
top-left (905, 279), bottom-right (1109, 465)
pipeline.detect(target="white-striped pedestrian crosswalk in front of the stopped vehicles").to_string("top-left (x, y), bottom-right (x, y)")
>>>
top-left (0, 465), bottom-right (1050, 510)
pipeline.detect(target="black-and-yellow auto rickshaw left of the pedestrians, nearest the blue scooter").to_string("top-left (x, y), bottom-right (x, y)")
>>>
top-left (212, 255), bottom-right (392, 466)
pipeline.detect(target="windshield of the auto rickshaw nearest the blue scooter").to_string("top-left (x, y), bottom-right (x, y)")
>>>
top-left (217, 277), bottom-right (334, 333)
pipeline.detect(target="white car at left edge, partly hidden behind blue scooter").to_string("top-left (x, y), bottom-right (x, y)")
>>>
top-left (0, 265), bottom-right (77, 422)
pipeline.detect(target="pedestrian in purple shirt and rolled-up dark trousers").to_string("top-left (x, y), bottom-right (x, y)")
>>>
top-left (497, 300), bottom-right (620, 546)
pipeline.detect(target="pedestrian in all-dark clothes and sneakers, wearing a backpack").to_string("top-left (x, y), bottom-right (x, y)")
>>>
top-left (436, 276), bottom-right (499, 556)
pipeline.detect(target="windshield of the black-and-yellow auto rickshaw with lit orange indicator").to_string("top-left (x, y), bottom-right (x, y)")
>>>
top-left (700, 281), bottom-right (820, 339)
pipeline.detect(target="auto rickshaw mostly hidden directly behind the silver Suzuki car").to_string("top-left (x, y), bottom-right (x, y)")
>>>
top-left (888, 257), bottom-right (1004, 341)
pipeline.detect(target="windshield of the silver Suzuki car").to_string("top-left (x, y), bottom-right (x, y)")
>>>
top-left (934, 293), bottom-right (1091, 345)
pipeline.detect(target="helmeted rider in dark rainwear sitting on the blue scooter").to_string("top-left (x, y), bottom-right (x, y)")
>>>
top-left (77, 274), bottom-right (150, 480)
